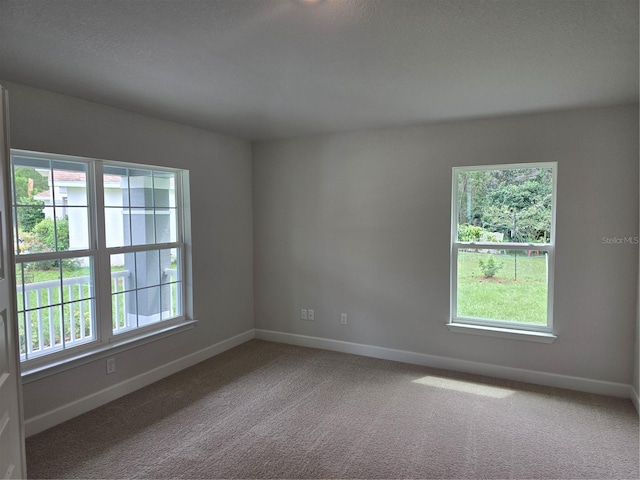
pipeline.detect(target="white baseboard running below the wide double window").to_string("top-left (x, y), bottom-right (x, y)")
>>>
top-left (24, 330), bottom-right (254, 437)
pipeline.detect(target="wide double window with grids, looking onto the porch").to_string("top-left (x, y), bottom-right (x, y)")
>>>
top-left (11, 150), bottom-right (188, 366)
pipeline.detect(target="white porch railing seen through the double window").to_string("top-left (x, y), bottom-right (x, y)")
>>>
top-left (18, 269), bottom-right (182, 360)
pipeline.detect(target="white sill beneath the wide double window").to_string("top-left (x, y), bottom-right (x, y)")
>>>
top-left (22, 320), bottom-right (198, 384)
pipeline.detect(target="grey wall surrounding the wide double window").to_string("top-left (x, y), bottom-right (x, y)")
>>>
top-left (3, 82), bottom-right (253, 419)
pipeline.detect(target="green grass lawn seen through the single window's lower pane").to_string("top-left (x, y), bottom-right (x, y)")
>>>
top-left (458, 251), bottom-right (547, 325)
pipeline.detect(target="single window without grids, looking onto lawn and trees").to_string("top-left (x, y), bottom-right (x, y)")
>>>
top-left (449, 163), bottom-right (557, 341)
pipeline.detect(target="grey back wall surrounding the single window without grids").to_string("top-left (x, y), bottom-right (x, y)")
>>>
top-left (253, 105), bottom-right (638, 384)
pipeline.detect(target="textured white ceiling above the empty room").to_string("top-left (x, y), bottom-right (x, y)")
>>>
top-left (0, 0), bottom-right (639, 140)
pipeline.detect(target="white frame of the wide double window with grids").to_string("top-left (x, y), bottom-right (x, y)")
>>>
top-left (11, 149), bottom-right (195, 374)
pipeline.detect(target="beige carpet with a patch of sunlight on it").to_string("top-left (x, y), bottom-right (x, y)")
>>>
top-left (27, 340), bottom-right (640, 479)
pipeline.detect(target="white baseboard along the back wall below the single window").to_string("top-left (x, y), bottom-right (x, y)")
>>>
top-left (255, 329), bottom-right (638, 402)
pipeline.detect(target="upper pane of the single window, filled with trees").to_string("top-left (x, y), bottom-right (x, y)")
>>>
top-left (455, 167), bottom-right (553, 243)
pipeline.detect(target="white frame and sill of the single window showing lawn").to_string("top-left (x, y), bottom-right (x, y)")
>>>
top-left (447, 162), bottom-right (558, 343)
